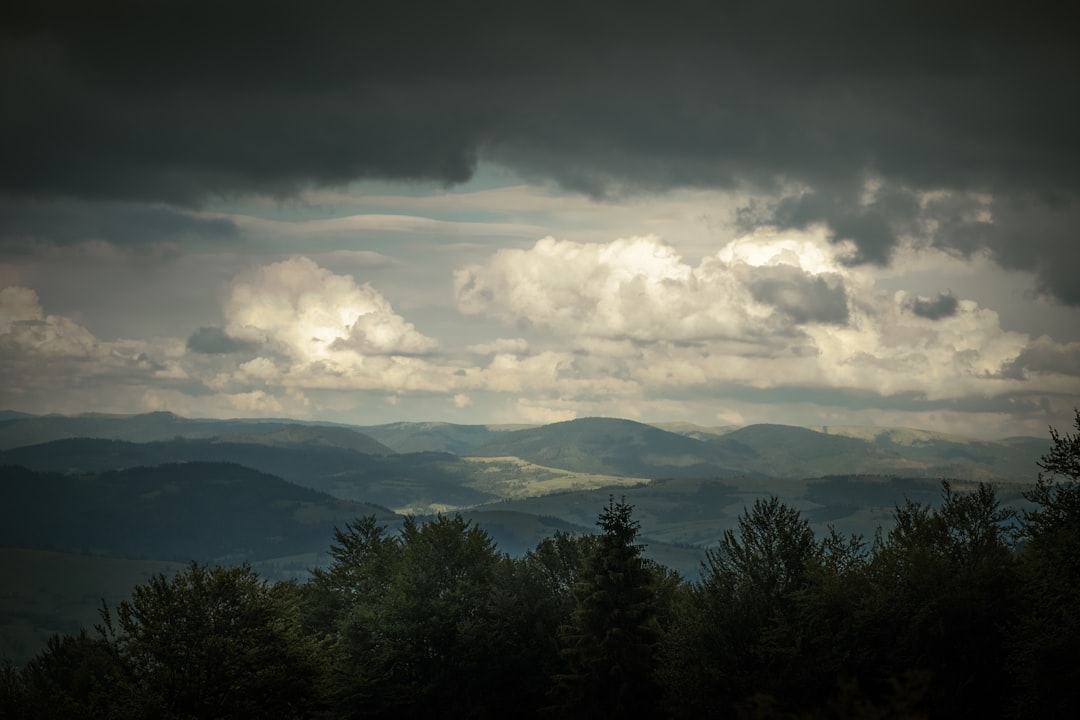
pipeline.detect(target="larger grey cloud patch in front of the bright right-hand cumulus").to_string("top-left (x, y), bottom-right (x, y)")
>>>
top-left (743, 266), bottom-right (848, 325)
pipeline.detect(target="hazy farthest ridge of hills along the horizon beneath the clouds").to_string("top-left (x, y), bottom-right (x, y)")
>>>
top-left (0, 410), bottom-right (1045, 483)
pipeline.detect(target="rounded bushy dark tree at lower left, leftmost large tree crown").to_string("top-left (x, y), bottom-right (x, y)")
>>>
top-left (103, 562), bottom-right (319, 719)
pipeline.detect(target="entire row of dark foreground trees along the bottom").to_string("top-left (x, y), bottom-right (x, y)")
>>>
top-left (6, 411), bottom-right (1080, 720)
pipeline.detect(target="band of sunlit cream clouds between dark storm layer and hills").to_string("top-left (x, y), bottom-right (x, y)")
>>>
top-left (0, 186), bottom-right (1078, 434)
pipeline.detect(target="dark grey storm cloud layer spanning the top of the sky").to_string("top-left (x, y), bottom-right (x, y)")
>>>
top-left (0, 0), bottom-right (1080, 303)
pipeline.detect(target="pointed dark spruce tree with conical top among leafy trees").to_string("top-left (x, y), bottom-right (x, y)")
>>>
top-left (553, 498), bottom-right (660, 718)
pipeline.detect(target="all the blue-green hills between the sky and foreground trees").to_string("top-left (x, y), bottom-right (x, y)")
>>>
top-left (0, 411), bottom-right (1049, 656)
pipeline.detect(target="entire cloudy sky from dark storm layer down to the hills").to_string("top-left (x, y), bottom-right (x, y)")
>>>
top-left (0, 0), bottom-right (1080, 438)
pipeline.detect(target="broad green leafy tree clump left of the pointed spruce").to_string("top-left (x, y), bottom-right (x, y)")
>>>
top-left (316, 516), bottom-right (502, 717)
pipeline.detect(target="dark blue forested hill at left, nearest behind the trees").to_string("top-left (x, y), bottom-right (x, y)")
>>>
top-left (0, 463), bottom-right (397, 562)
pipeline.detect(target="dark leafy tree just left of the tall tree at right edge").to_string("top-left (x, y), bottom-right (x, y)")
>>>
top-left (858, 483), bottom-right (1021, 717)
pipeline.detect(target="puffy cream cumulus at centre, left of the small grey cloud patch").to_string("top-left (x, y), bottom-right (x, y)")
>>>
top-left (455, 235), bottom-right (785, 342)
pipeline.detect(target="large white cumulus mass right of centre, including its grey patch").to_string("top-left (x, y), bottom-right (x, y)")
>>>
top-left (456, 231), bottom-right (1045, 408)
